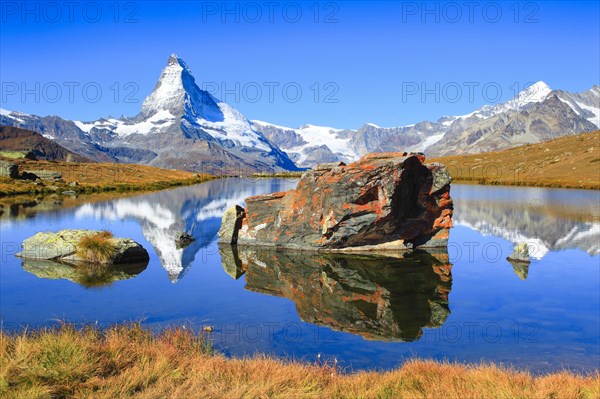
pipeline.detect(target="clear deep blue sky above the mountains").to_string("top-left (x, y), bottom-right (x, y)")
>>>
top-left (0, 0), bottom-right (600, 128)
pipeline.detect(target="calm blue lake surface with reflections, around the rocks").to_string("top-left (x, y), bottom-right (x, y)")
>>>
top-left (0, 179), bottom-right (600, 372)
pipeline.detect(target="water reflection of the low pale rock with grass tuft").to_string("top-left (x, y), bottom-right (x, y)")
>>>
top-left (23, 259), bottom-right (148, 288)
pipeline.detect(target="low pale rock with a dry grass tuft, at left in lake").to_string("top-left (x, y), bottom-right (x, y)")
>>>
top-left (17, 230), bottom-right (150, 264)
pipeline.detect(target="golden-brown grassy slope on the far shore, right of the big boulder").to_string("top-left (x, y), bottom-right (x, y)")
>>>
top-left (428, 130), bottom-right (600, 189)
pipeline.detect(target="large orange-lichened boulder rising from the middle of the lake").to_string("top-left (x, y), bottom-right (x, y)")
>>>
top-left (219, 153), bottom-right (452, 250)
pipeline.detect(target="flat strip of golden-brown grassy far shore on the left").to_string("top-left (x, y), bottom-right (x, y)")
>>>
top-left (0, 159), bottom-right (214, 196)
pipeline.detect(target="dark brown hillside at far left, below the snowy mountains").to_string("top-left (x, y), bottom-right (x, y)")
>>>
top-left (0, 126), bottom-right (92, 162)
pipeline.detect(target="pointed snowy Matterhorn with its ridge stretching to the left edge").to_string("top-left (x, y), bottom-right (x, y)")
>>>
top-left (0, 55), bottom-right (296, 174)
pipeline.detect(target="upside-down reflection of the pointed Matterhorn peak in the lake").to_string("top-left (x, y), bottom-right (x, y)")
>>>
top-left (76, 179), bottom-right (294, 282)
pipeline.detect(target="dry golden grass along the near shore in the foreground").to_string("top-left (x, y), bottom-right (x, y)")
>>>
top-left (0, 325), bottom-right (600, 399)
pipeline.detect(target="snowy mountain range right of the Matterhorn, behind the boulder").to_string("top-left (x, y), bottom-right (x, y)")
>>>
top-left (252, 82), bottom-right (600, 167)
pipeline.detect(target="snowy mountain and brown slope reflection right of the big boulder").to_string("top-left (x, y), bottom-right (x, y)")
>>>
top-left (452, 185), bottom-right (600, 259)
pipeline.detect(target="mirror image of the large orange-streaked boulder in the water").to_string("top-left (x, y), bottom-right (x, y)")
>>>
top-left (221, 245), bottom-right (452, 341)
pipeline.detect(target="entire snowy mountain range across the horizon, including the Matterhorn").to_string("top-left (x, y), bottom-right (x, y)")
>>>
top-left (0, 55), bottom-right (600, 174)
